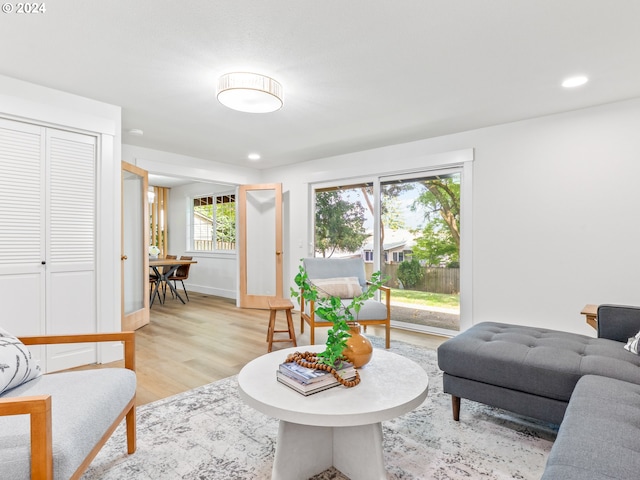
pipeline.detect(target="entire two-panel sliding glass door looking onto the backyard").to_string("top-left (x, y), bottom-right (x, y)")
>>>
top-left (314, 168), bottom-right (462, 334)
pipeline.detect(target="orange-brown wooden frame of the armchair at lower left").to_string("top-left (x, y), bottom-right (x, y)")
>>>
top-left (0, 332), bottom-right (136, 480)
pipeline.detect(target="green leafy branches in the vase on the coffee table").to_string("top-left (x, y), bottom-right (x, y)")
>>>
top-left (291, 264), bottom-right (385, 367)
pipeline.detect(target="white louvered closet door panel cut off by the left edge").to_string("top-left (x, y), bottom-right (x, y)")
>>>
top-left (0, 119), bottom-right (45, 359)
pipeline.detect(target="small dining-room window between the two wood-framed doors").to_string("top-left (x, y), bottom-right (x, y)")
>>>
top-left (192, 194), bottom-right (236, 252)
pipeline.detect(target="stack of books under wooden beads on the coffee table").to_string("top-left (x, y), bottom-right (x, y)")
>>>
top-left (276, 362), bottom-right (356, 396)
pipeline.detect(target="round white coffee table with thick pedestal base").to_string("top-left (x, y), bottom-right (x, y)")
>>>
top-left (238, 345), bottom-right (429, 480)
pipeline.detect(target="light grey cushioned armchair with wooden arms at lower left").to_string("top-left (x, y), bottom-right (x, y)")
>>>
top-left (0, 332), bottom-right (136, 480)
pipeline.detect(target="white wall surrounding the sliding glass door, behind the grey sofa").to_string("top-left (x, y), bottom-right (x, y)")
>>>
top-left (264, 99), bottom-right (640, 335)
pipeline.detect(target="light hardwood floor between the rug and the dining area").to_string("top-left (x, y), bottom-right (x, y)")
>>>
top-left (105, 292), bottom-right (446, 405)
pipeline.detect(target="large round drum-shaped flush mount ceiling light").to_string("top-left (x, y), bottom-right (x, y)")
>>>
top-left (218, 72), bottom-right (282, 113)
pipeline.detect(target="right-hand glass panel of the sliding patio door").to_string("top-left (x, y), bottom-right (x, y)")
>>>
top-left (376, 170), bottom-right (461, 331)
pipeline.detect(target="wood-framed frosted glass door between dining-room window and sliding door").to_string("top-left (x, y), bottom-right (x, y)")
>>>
top-left (238, 183), bottom-right (283, 309)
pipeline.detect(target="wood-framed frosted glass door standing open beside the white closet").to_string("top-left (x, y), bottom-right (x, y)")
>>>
top-left (120, 162), bottom-right (149, 330)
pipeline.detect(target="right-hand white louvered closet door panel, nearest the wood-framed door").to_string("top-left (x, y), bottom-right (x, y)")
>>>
top-left (45, 129), bottom-right (96, 371)
